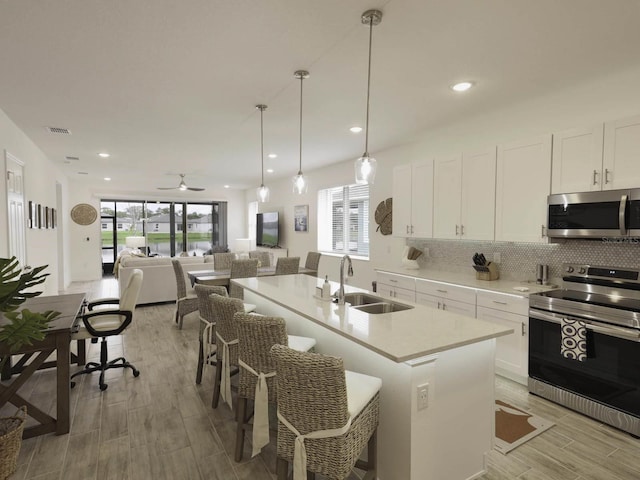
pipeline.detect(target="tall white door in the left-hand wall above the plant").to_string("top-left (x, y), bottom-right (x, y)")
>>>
top-left (5, 150), bottom-right (27, 266)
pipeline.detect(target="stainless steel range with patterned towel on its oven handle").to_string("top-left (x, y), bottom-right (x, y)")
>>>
top-left (529, 264), bottom-right (640, 436)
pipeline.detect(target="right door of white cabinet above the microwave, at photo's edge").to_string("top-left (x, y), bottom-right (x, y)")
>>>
top-left (602, 116), bottom-right (640, 190)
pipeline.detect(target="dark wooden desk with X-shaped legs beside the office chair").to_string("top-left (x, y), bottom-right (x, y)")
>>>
top-left (0, 293), bottom-right (86, 438)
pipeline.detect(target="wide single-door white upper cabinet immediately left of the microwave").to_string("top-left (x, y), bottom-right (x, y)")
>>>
top-left (495, 134), bottom-right (551, 242)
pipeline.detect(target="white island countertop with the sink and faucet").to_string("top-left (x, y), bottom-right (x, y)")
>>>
top-left (232, 275), bottom-right (513, 362)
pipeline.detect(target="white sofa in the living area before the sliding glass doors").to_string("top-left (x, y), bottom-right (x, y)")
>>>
top-left (118, 255), bottom-right (213, 305)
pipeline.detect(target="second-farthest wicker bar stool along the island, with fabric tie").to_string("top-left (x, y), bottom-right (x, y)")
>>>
top-left (210, 294), bottom-right (244, 409)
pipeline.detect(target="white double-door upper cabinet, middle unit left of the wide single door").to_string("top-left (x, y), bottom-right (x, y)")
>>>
top-left (433, 147), bottom-right (496, 240)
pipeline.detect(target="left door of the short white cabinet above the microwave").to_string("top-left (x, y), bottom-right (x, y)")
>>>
top-left (551, 123), bottom-right (607, 193)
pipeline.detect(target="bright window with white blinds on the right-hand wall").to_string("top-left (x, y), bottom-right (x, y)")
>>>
top-left (318, 185), bottom-right (369, 258)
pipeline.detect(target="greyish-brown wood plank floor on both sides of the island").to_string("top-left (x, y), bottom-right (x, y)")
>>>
top-left (1, 279), bottom-right (640, 480)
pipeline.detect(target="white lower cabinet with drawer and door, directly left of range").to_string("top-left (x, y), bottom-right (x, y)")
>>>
top-left (476, 291), bottom-right (529, 384)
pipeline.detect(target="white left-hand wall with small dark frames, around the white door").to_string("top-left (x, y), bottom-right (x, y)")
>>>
top-left (0, 110), bottom-right (68, 295)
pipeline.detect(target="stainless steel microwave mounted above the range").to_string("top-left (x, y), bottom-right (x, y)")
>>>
top-left (547, 188), bottom-right (640, 239)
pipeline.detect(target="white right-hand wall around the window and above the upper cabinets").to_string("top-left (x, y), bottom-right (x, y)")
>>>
top-left (246, 63), bottom-right (640, 289)
